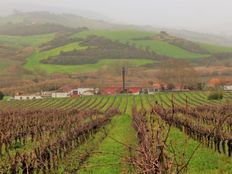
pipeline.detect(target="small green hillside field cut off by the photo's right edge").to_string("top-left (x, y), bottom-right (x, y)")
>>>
top-left (200, 43), bottom-right (232, 53)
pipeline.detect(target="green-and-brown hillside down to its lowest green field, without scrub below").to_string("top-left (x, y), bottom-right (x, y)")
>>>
top-left (0, 24), bottom-right (232, 74)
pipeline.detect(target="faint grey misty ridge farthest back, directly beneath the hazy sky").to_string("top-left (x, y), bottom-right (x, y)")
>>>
top-left (0, 11), bottom-right (232, 46)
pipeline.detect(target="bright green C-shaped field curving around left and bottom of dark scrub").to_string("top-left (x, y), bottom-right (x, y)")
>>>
top-left (24, 40), bottom-right (154, 73)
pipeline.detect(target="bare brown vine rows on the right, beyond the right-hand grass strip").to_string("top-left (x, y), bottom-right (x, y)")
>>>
top-left (152, 105), bottom-right (232, 156)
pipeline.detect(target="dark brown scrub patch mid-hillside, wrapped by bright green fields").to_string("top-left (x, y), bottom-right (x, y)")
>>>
top-left (42, 36), bottom-right (166, 65)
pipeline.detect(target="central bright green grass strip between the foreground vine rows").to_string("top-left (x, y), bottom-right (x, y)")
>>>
top-left (78, 115), bottom-right (136, 174)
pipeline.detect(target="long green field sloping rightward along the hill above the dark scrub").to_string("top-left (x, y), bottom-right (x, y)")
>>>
top-left (72, 30), bottom-right (207, 59)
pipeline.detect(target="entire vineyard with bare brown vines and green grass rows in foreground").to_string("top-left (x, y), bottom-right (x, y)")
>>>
top-left (0, 92), bottom-right (232, 174)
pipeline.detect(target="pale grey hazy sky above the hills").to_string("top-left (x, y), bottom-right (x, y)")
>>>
top-left (0, 0), bottom-right (232, 33)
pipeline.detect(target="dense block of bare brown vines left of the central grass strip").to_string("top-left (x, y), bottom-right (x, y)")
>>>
top-left (0, 108), bottom-right (119, 174)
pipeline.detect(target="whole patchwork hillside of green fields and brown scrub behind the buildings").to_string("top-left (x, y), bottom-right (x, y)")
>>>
top-left (0, 24), bottom-right (232, 87)
